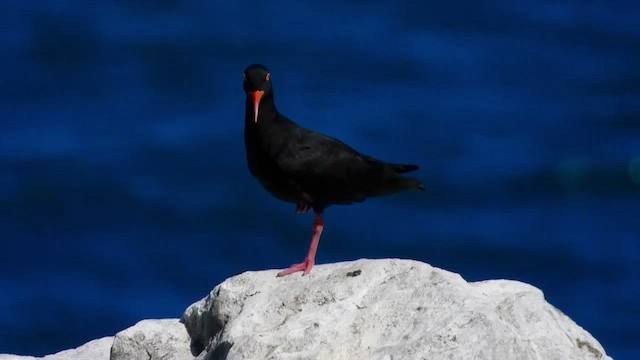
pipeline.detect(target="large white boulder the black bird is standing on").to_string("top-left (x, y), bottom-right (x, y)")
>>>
top-left (182, 260), bottom-right (610, 360)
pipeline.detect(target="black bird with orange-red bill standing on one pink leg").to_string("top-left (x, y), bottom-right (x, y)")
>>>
top-left (243, 64), bottom-right (424, 276)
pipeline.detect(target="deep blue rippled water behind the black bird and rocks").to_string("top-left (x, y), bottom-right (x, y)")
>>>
top-left (0, 0), bottom-right (640, 359)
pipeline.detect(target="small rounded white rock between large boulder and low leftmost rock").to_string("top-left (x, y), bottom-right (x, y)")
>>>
top-left (110, 319), bottom-right (194, 360)
